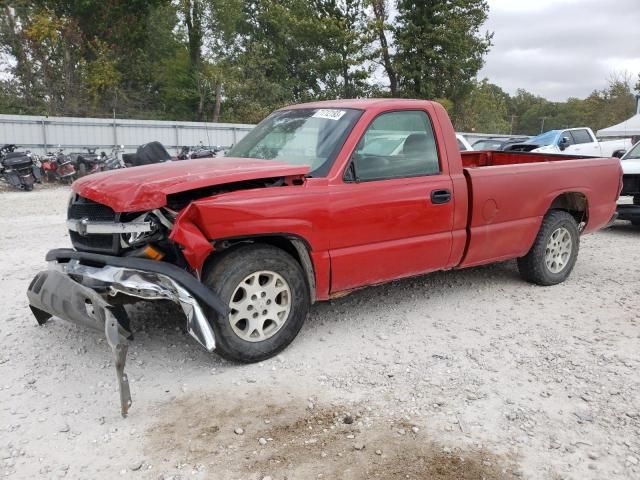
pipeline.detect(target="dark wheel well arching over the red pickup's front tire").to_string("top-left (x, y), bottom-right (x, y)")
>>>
top-left (205, 234), bottom-right (316, 303)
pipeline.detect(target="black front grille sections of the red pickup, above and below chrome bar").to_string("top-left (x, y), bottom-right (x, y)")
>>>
top-left (67, 195), bottom-right (120, 255)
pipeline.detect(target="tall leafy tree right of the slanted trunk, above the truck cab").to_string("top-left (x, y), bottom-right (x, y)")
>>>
top-left (394, 0), bottom-right (492, 104)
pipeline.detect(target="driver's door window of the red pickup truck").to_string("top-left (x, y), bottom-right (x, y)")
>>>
top-left (346, 110), bottom-right (440, 181)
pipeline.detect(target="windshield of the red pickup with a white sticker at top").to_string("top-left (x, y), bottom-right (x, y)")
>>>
top-left (227, 108), bottom-right (362, 176)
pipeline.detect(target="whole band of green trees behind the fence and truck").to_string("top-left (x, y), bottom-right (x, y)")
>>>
top-left (0, 0), bottom-right (640, 134)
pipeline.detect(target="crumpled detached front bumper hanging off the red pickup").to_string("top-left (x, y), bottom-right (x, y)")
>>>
top-left (27, 249), bottom-right (227, 416)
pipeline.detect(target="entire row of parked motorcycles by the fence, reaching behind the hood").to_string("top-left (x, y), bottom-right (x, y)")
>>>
top-left (0, 142), bottom-right (225, 191)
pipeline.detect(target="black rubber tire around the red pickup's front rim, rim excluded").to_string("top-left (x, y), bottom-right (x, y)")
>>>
top-left (203, 244), bottom-right (311, 363)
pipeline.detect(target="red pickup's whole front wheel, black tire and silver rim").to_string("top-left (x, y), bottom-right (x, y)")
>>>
top-left (204, 244), bottom-right (311, 363)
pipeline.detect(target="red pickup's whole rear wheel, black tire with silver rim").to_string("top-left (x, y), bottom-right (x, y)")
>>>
top-left (518, 210), bottom-right (580, 286)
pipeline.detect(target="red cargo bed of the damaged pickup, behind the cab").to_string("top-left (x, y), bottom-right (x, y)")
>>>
top-left (459, 151), bottom-right (620, 267)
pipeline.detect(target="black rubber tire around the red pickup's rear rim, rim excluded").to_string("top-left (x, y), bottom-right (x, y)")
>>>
top-left (518, 210), bottom-right (580, 286)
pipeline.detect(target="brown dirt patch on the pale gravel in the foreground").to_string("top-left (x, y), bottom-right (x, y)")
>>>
top-left (145, 391), bottom-right (516, 480)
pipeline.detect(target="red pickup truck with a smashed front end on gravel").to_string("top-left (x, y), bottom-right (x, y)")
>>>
top-left (28, 99), bottom-right (621, 414)
